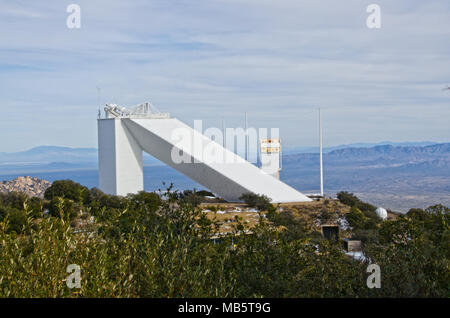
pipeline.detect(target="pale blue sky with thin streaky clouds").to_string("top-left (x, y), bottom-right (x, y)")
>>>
top-left (0, 0), bottom-right (450, 151)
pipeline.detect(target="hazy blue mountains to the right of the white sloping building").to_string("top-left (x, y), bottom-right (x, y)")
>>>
top-left (281, 143), bottom-right (450, 211)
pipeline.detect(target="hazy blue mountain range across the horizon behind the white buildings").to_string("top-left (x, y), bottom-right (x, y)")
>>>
top-left (0, 142), bottom-right (450, 212)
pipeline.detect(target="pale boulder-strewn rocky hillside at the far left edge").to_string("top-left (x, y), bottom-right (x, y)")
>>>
top-left (0, 176), bottom-right (51, 198)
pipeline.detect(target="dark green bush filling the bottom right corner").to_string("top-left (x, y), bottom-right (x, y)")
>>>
top-left (365, 206), bottom-right (450, 297)
